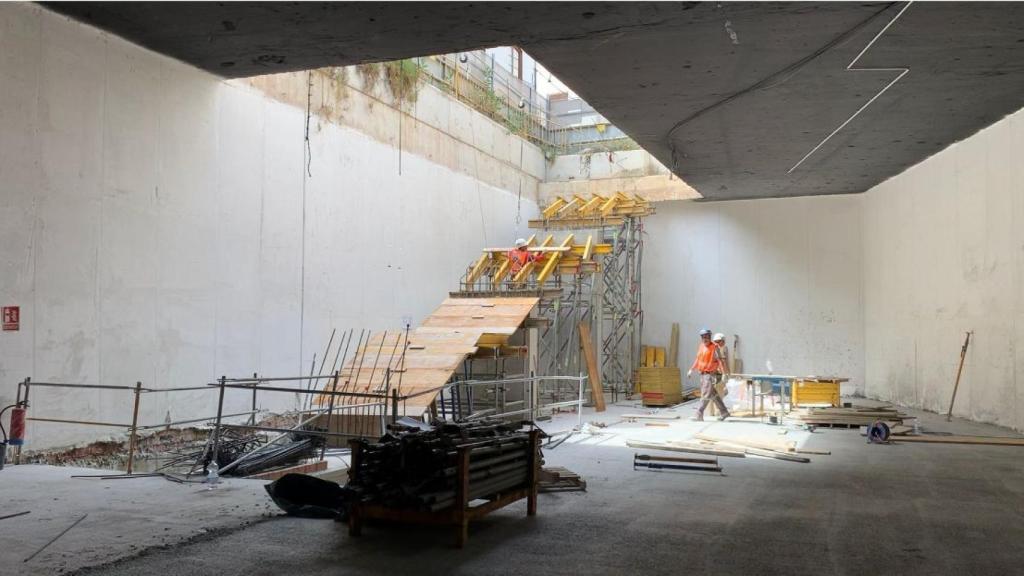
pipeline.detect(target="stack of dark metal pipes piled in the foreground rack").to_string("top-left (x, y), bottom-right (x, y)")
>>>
top-left (346, 421), bottom-right (540, 511)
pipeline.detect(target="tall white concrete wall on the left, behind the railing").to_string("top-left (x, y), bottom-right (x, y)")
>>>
top-left (0, 3), bottom-right (536, 448)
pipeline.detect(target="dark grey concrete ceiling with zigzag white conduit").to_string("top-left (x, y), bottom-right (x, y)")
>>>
top-left (46, 2), bottom-right (1024, 200)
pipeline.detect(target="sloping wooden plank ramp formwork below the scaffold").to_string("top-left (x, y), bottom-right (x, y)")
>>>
top-left (316, 297), bottom-right (539, 437)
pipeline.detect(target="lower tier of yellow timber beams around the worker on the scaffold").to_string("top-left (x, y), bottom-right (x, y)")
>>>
top-left (465, 234), bottom-right (611, 289)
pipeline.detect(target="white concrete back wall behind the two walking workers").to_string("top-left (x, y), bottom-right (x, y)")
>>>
top-left (643, 196), bottom-right (864, 393)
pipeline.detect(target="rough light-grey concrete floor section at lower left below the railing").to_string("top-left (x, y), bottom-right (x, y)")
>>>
top-left (0, 464), bottom-right (280, 576)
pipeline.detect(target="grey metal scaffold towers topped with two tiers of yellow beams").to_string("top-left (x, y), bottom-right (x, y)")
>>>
top-left (452, 193), bottom-right (654, 402)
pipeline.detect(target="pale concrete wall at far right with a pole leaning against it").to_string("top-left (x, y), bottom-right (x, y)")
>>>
top-left (864, 112), bottom-right (1024, 429)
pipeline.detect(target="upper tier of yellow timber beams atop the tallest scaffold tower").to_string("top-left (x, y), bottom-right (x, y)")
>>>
top-left (529, 192), bottom-right (654, 229)
